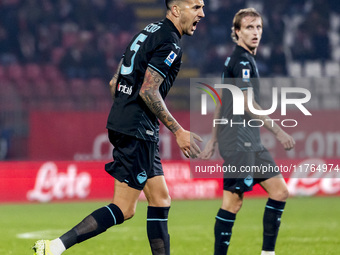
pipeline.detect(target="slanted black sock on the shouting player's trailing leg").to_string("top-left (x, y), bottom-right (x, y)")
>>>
top-left (60, 204), bottom-right (124, 249)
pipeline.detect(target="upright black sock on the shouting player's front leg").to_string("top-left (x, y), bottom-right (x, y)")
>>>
top-left (147, 206), bottom-right (170, 255)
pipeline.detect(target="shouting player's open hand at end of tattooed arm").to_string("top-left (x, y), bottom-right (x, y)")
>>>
top-left (175, 129), bottom-right (202, 158)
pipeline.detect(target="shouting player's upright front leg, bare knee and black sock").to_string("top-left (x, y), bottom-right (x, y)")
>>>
top-left (143, 175), bottom-right (171, 255)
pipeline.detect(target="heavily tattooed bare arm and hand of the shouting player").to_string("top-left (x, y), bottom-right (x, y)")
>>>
top-left (139, 67), bottom-right (202, 158)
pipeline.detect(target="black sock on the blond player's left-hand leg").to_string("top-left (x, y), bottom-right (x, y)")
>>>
top-left (214, 209), bottom-right (236, 255)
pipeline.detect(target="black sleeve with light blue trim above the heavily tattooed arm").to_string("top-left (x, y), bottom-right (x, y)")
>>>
top-left (148, 43), bottom-right (182, 78)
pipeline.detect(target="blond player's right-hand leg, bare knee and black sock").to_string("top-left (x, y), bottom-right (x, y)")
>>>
top-left (260, 175), bottom-right (288, 255)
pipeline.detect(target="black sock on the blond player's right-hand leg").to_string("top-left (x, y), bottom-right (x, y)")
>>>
top-left (262, 198), bottom-right (286, 251)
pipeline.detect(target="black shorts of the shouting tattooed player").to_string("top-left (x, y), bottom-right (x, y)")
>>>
top-left (105, 130), bottom-right (164, 190)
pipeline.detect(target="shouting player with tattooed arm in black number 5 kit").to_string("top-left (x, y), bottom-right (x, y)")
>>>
top-left (33, 0), bottom-right (204, 255)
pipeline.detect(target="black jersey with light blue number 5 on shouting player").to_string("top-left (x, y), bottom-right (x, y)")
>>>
top-left (107, 19), bottom-right (182, 142)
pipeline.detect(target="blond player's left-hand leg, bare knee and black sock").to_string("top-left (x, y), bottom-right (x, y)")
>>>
top-left (214, 190), bottom-right (243, 255)
